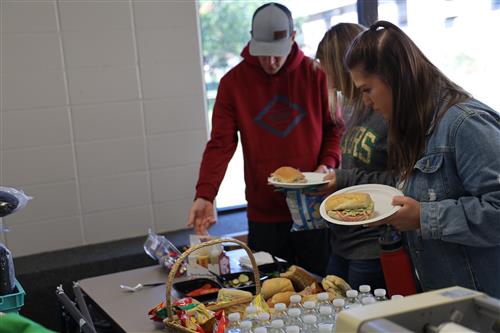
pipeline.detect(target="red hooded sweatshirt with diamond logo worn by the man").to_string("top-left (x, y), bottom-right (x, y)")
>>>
top-left (196, 43), bottom-right (344, 223)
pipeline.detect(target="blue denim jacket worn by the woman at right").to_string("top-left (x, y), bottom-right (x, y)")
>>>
top-left (403, 95), bottom-right (500, 298)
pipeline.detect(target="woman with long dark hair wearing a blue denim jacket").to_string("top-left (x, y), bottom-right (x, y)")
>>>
top-left (345, 21), bottom-right (500, 298)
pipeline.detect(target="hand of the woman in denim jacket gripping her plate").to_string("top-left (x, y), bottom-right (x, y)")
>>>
top-left (368, 195), bottom-right (420, 231)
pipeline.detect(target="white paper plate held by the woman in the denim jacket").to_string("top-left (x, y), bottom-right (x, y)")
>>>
top-left (319, 184), bottom-right (404, 225)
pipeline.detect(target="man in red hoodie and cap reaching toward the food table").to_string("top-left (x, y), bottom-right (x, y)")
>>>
top-left (188, 3), bottom-right (343, 272)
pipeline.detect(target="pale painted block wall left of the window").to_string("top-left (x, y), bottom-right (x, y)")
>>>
top-left (0, 0), bottom-right (208, 257)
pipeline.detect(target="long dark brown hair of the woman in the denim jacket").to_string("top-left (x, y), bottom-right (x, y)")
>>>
top-left (344, 21), bottom-right (470, 179)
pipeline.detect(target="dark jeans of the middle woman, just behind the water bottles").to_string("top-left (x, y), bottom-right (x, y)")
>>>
top-left (326, 253), bottom-right (386, 291)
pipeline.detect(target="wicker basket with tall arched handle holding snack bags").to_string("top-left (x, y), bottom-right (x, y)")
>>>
top-left (163, 238), bottom-right (260, 333)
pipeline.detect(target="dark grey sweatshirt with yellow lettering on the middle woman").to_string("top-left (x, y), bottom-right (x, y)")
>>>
top-left (329, 111), bottom-right (395, 260)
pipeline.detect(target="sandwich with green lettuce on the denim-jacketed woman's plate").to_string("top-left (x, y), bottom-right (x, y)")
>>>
top-left (325, 192), bottom-right (375, 222)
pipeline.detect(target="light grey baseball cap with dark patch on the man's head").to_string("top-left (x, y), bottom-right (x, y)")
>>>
top-left (250, 2), bottom-right (293, 57)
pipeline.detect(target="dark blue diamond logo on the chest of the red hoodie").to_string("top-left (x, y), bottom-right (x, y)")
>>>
top-left (255, 95), bottom-right (306, 138)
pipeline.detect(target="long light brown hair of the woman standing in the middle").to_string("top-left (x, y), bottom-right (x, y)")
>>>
top-left (316, 23), bottom-right (366, 124)
